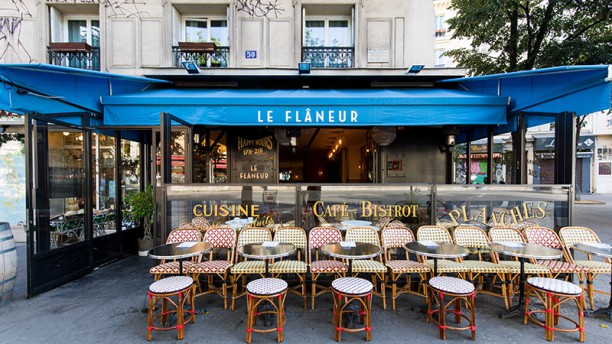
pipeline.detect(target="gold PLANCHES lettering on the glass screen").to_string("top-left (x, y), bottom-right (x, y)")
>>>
top-left (447, 202), bottom-right (548, 226)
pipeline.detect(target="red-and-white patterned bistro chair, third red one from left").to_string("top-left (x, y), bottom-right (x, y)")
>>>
top-left (307, 227), bottom-right (348, 309)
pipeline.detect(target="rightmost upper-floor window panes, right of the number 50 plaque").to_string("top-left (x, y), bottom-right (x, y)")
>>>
top-left (304, 18), bottom-right (353, 47)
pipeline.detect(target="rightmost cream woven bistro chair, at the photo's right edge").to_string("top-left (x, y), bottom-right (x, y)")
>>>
top-left (559, 227), bottom-right (610, 309)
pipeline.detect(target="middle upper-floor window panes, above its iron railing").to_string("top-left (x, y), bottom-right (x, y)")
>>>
top-left (184, 17), bottom-right (229, 46)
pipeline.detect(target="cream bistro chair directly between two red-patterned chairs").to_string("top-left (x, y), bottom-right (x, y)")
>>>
top-left (344, 226), bottom-right (387, 309)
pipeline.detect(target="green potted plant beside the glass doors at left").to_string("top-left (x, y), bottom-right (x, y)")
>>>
top-left (125, 185), bottom-right (154, 256)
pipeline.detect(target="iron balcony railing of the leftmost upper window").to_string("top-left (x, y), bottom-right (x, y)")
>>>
top-left (47, 42), bottom-right (100, 70)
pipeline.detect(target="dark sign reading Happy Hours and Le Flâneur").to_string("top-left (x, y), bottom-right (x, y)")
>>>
top-left (230, 129), bottom-right (278, 183)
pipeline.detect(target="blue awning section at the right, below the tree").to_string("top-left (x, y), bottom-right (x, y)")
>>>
top-left (443, 65), bottom-right (612, 120)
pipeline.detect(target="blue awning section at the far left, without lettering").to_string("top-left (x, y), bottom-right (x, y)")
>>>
top-left (0, 64), bottom-right (169, 114)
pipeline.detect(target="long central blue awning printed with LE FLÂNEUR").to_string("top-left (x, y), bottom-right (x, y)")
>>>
top-left (102, 89), bottom-right (508, 126)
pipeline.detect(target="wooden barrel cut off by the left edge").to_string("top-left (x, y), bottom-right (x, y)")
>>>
top-left (0, 222), bottom-right (17, 307)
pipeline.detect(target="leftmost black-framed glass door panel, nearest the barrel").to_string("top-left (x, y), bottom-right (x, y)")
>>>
top-left (26, 116), bottom-right (92, 296)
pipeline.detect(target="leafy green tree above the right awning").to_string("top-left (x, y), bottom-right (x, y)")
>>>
top-left (446, 0), bottom-right (612, 75)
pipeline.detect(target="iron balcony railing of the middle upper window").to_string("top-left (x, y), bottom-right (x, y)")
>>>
top-left (172, 42), bottom-right (229, 68)
